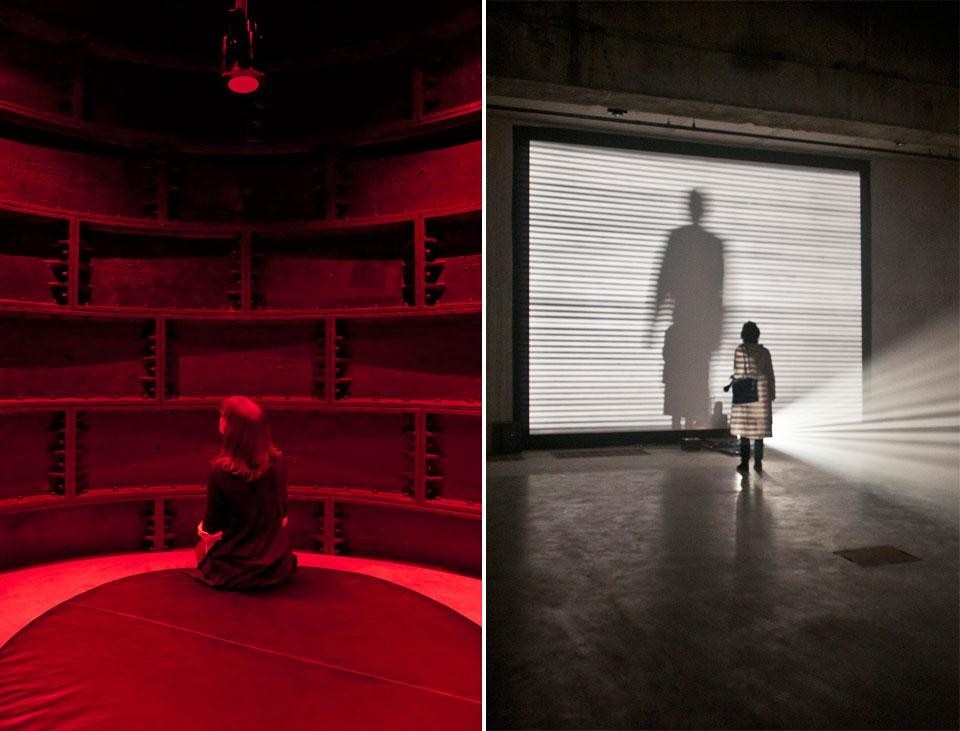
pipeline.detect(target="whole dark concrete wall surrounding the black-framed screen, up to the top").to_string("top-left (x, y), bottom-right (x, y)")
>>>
top-left (486, 2), bottom-right (960, 440)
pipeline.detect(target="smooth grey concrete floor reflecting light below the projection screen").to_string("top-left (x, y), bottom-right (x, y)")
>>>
top-left (486, 447), bottom-right (960, 729)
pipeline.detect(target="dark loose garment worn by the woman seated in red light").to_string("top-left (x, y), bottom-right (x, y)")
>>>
top-left (198, 457), bottom-right (297, 589)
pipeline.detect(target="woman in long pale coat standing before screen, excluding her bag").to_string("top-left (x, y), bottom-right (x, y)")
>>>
top-left (730, 322), bottom-right (777, 472)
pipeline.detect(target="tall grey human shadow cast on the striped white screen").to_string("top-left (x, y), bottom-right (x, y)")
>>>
top-left (651, 189), bottom-right (724, 429)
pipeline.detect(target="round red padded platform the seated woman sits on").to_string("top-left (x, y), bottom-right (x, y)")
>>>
top-left (0, 568), bottom-right (481, 729)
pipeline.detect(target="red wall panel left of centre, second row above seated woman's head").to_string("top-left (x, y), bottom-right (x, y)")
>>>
top-left (82, 231), bottom-right (239, 308)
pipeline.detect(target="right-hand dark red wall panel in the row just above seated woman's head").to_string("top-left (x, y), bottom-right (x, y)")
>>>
top-left (341, 314), bottom-right (481, 401)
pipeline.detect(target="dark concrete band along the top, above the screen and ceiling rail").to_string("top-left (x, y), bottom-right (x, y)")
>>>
top-left (487, 0), bottom-right (958, 152)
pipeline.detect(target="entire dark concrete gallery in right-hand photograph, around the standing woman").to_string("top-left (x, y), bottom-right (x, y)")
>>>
top-left (485, 0), bottom-right (960, 729)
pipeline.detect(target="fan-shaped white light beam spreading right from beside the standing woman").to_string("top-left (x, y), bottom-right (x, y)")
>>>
top-left (769, 311), bottom-right (960, 510)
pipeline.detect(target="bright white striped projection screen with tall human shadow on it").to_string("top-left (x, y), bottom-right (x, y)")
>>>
top-left (527, 139), bottom-right (863, 436)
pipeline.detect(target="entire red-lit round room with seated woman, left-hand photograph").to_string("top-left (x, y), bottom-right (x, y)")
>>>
top-left (0, 0), bottom-right (482, 729)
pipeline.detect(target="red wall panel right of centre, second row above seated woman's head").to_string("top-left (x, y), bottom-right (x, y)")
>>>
top-left (254, 224), bottom-right (413, 308)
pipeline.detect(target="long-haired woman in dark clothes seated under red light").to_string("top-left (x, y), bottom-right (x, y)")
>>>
top-left (197, 396), bottom-right (297, 589)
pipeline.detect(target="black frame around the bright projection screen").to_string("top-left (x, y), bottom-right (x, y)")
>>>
top-left (512, 125), bottom-right (872, 449)
